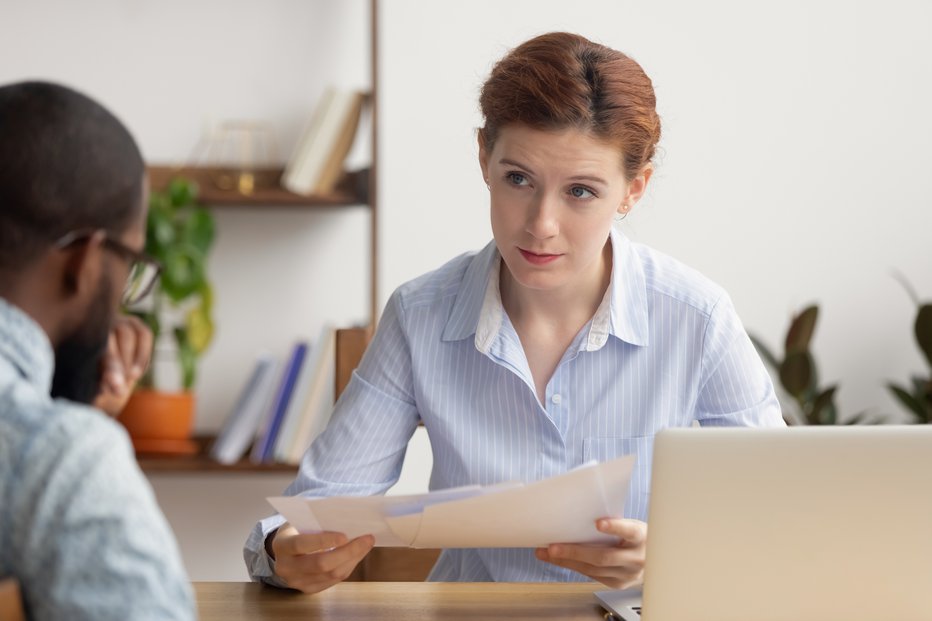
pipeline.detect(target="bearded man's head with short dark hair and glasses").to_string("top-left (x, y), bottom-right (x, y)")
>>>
top-left (0, 82), bottom-right (147, 403)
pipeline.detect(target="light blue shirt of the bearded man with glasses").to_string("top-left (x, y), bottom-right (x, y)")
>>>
top-left (0, 298), bottom-right (196, 621)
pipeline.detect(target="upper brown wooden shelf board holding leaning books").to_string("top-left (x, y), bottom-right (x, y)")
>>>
top-left (148, 166), bottom-right (369, 208)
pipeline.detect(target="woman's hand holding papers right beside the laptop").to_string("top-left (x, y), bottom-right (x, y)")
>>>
top-left (536, 518), bottom-right (647, 589)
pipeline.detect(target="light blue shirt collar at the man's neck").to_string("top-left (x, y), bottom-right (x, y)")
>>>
top-left (0, 298), bottom-right (55, 394)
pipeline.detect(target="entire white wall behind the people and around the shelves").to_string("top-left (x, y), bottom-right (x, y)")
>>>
top-left (0, 0), bottom-right (932, 580)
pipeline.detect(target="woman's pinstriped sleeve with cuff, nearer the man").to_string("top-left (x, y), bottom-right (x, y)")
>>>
top-left (243, 291), bottom-right (419, 587)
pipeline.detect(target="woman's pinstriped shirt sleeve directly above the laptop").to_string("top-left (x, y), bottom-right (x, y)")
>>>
top-left (696, 294), bottom-right (785, 427)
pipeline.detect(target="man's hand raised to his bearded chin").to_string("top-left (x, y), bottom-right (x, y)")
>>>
top-left (94, 315), bottom-right (152, 416)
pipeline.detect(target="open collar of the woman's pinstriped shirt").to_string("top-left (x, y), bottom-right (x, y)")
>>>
top-left (442, 227), bottom-right (648, 352)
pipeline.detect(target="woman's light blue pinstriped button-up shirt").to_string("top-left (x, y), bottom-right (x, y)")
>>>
top-left (245, 231), bottom-right (784, 584)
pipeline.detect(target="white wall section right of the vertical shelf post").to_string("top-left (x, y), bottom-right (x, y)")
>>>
top-left (380, 0), bottom-right (932, 418)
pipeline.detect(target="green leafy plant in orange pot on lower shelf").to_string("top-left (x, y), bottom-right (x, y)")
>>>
top-left (120, 177), bottom-right (214, 452)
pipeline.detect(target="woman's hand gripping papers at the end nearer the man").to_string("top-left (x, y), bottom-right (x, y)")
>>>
top-left (271, 523), bottom-right (375, 593)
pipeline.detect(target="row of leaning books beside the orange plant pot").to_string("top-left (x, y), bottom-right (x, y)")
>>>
top-left (210, 326), bottom-right (336, 464)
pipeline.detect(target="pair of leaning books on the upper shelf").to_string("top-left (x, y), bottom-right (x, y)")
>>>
top-left (282, 87), bottom-right (366, 195)
